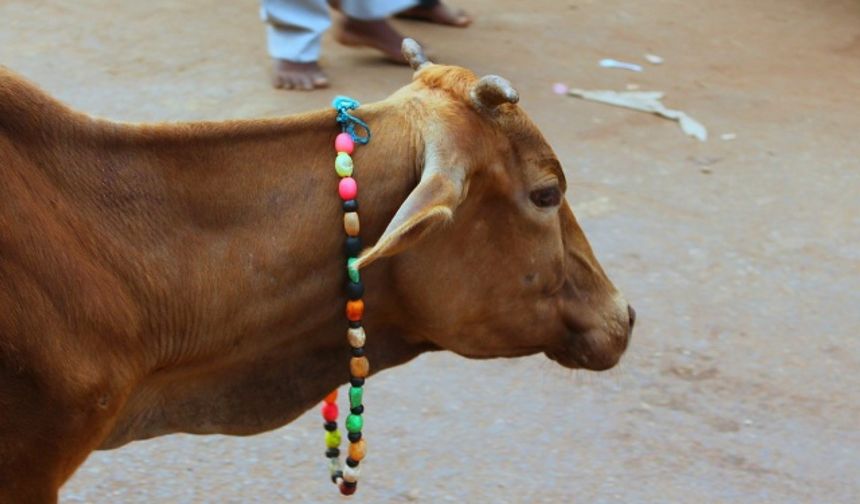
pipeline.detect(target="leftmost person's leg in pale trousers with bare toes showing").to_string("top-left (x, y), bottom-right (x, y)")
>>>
top-left (260, 0), bottom-right (331, 90)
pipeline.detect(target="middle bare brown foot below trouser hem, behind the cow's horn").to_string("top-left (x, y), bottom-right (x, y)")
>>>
top-left (335, 0), bottom-right (418, 64)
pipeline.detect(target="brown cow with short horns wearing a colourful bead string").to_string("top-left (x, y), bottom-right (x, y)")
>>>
top-left (0, 42), bottom-right (633, 503)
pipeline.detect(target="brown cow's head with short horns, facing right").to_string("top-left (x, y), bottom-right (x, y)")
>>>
top-left (359, 39), bottom-right (634, 370)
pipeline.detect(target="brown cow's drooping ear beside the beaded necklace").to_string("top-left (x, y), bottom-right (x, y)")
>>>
top-left (356, 167), bottom-right (465, 268)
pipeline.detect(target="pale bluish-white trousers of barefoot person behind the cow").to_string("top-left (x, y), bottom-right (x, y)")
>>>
top-left (260, 0), bottom-right (419, 63)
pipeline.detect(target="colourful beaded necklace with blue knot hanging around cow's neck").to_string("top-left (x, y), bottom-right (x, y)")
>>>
top-left (322, 96), bottom-right (370, 495)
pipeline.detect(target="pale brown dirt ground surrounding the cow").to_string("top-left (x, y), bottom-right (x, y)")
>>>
top-left (0, 0), bottom-right (860, 503)
